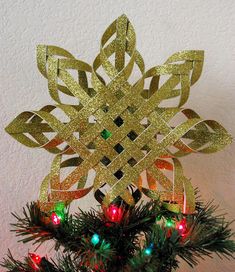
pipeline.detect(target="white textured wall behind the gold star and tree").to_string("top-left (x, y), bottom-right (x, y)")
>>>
top-left (0, 0), bottom-right (235, 272)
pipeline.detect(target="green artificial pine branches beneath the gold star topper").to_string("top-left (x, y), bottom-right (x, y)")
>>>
top-left (2, 200), bottom-right (235, 272)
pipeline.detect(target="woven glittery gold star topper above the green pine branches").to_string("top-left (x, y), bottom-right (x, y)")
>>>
top-left (6, 15), bottom-right (231, 213)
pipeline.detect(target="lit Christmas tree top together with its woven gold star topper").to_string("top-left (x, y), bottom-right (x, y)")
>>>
top-left (1, 15), bottom-right (235, 272)
